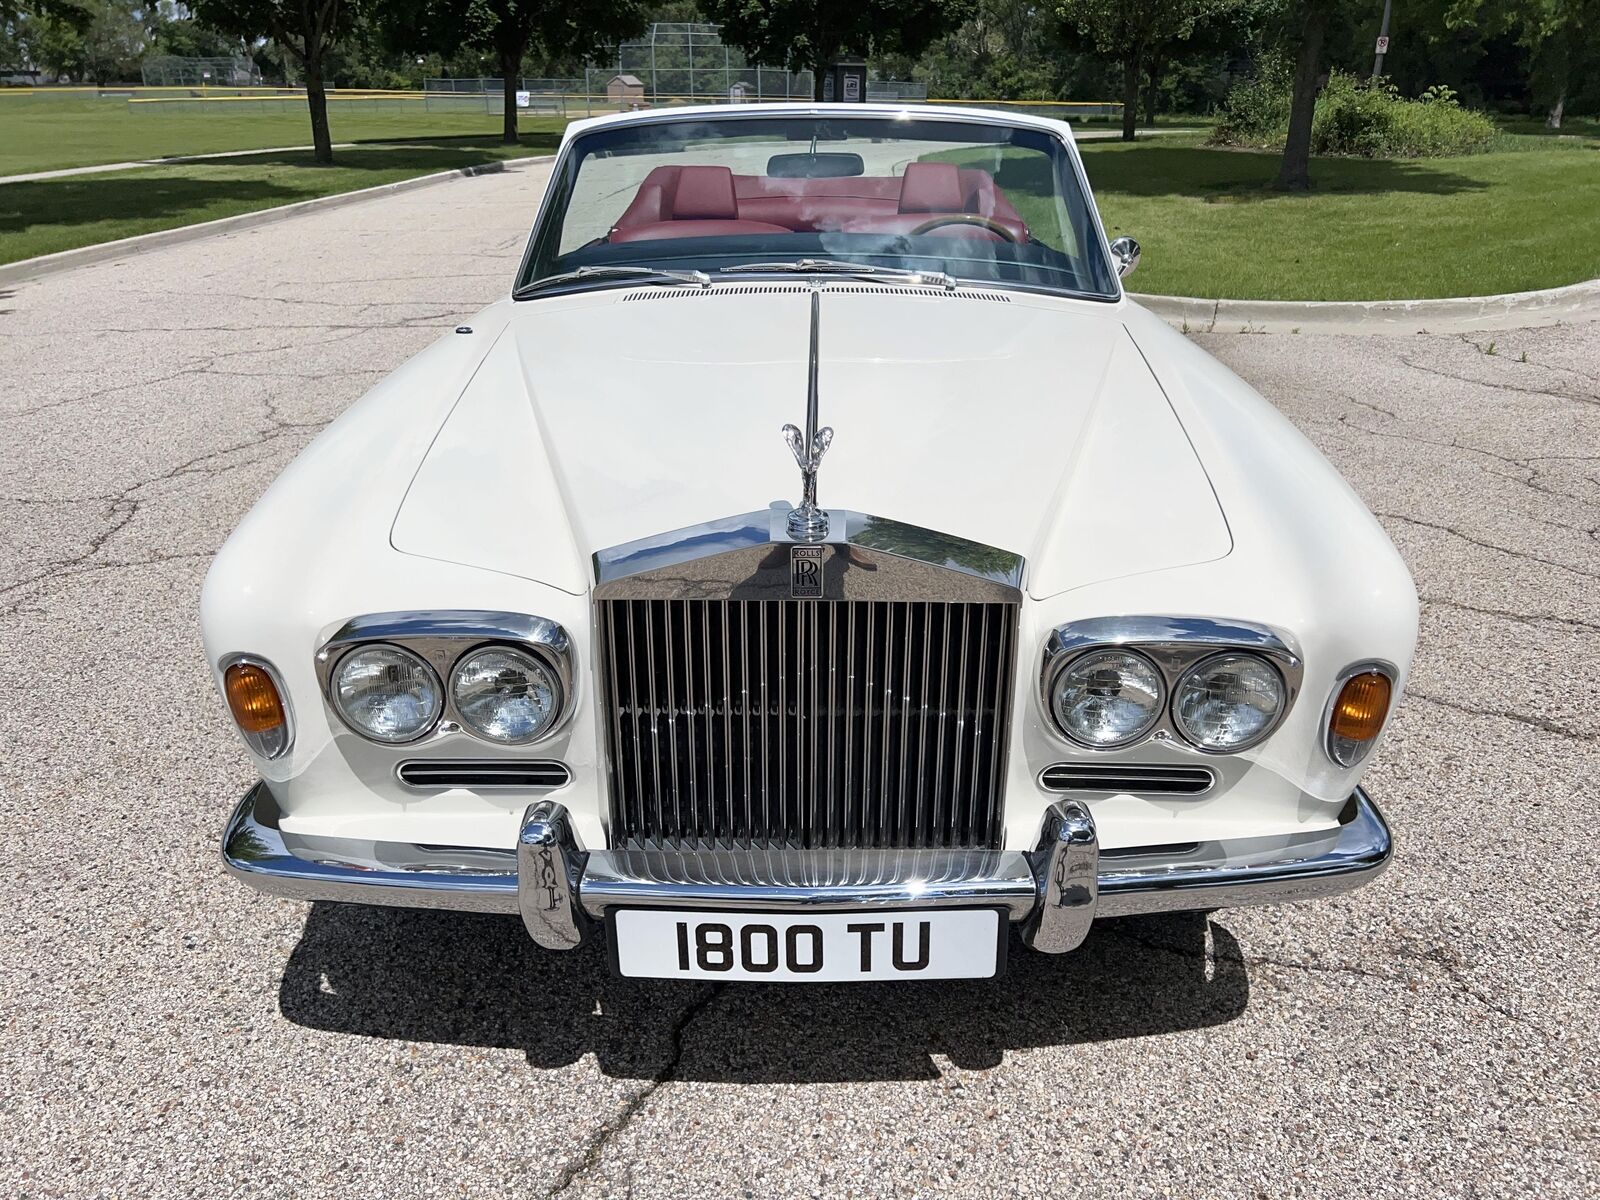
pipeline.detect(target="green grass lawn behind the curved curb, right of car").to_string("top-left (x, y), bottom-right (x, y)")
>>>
top-left (1083, 136), bottom-right (1600, 299)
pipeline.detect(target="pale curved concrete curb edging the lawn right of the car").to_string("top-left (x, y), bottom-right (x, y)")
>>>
top-left (1128, 280), bottom-right (1600, 334)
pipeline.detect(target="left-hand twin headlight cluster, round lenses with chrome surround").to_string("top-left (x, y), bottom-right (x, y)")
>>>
top-left (318, 613), bottom-right (571, 746)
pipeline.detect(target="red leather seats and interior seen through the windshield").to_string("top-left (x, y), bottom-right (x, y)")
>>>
top-left (611, 163), bottom-right (1027, 242)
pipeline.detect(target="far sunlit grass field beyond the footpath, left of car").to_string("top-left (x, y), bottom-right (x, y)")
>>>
top-left (0, 91), bottom-right (566, 176)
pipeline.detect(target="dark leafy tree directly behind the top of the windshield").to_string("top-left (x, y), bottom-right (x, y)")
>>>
top-left (699, 0), bottom-right (976, 99)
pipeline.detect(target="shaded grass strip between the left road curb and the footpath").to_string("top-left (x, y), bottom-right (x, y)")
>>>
top-left (0, 133), bottom-right (557, 262)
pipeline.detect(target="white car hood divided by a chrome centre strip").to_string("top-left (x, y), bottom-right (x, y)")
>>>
top-left (390, 283), bottom-right (1230, 597)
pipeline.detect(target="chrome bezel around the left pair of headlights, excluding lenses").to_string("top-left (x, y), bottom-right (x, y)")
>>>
top-left (315, 610), bottom-right (578, 749)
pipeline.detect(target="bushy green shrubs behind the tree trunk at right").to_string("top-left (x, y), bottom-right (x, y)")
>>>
top-left (1211, 67), bottom-right (1496, 158)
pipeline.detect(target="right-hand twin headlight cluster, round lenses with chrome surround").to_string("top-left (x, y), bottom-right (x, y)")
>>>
top-left (1043, 618), bottom-right (1301, 754)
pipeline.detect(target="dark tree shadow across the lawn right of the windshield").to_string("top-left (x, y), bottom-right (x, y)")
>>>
top-left (1068, 144), bottom-right (1488, 203)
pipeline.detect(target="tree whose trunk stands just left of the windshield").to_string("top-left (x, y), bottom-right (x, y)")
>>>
top-left (376, 0), bottom-right (646, 146)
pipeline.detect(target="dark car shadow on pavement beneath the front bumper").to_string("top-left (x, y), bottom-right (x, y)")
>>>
top-left (278, 904), bottom-right (1250, 1083)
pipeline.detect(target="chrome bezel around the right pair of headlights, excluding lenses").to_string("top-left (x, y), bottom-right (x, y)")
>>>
top-left (1038, 616), bottom-right (1304, 757)
